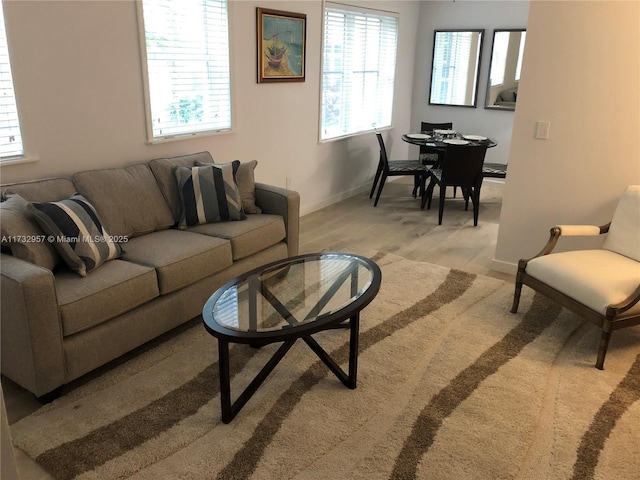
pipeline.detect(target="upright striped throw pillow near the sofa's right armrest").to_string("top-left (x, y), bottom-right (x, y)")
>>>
top-left (175, 160), bottom-right (247, 228)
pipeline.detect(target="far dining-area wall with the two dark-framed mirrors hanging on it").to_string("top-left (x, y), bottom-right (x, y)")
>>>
top-left (411, 0), bottom-right (529, 167)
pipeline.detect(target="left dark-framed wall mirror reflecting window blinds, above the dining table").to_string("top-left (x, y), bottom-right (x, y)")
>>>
top-left (429, 30), bottom-right (484, 107)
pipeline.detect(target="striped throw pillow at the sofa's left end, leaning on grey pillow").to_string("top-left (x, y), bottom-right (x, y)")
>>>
top-left (27, 195), bottom-right (124, 277)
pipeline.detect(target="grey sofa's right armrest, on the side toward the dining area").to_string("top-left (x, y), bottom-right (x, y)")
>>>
top-left (256, 183), bottom-right (300, 257)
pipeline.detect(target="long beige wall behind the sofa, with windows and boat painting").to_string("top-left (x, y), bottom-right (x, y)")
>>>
top-left (0, 0), bottom-right (420, 214)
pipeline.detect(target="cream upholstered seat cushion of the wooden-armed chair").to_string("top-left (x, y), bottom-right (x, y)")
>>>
top-left (527, 250), bottom-right (640, 315)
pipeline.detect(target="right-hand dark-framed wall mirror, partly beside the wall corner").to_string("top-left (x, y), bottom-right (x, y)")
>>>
top-left (484, 29), bottom-right (527, 110)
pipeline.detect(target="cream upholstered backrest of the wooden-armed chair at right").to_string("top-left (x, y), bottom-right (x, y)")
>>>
top-left (602, 185), bottom-right (640, 262)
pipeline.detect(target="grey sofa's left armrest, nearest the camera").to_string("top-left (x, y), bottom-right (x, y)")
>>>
top-left (0, 254), bottom-right (65, 397)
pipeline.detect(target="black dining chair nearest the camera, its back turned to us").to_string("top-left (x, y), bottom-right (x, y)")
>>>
top-left (421, 145), bottom-right (487, 227)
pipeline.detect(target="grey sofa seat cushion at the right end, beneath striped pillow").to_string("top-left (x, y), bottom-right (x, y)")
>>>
top-left (186, 213), bottom-right (286, 261)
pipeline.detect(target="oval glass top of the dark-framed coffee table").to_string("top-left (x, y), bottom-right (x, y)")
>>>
top-left (203, 253), bottom-right (380, 333)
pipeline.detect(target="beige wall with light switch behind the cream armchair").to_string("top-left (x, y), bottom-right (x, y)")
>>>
top-left (495, 1), bottom-right (640, 270)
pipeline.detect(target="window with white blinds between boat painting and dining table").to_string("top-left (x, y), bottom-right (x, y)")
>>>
top-left (320, 2), bottom-right (398, 140)
